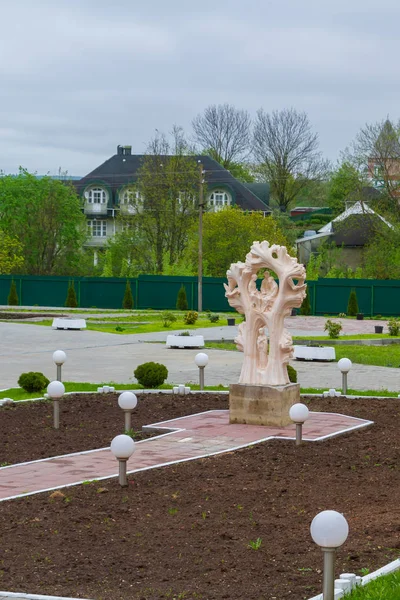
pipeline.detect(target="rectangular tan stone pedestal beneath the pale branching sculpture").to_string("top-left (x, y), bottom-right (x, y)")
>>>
top-left (229, 383), bottom-right (300, 427)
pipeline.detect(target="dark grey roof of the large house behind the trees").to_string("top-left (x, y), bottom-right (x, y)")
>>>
top-left (75, 154), bottom-right (270, 212)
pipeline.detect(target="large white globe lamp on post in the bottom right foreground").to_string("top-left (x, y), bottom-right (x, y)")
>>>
top-left (310, 510), bottom-right (349, 600)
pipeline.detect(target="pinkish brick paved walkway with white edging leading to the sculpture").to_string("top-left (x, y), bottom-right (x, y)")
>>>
top-left (0, 410), bottom-right (372, 501)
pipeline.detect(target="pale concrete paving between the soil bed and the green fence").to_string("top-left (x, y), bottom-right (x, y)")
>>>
top-left (0, 317), bottom-right (400, 393)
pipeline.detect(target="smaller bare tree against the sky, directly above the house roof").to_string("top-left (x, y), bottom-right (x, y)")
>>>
top-left (192, 104), bottom-right (251, 169)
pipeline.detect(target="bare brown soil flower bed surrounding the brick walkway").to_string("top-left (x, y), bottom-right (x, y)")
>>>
top-left (0, 394), bottom-right (400, 600)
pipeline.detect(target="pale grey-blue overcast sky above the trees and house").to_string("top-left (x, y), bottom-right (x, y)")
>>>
top-left (0, 0), bottom-right (400, 175)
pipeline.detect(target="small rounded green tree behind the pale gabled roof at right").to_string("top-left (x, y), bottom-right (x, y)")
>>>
top-left (327, 161), bottom-right (365, 216)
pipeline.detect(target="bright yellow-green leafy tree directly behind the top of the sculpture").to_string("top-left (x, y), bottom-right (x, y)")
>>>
top-left (188, 207), bottom-right (288, 277)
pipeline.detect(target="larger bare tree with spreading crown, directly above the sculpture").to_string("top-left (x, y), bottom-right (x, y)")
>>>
top-left (253, 108), bottom-right (329, 212)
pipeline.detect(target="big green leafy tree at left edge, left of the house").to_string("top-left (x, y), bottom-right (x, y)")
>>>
top-left (0, 169), bottom-right (87, 275)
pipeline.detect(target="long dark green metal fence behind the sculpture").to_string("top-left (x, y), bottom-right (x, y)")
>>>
top-left (0, 275), bottom-right (400, 316)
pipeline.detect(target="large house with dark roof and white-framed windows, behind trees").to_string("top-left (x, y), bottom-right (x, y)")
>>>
top-left (74, 146), bottom-right (271, 247)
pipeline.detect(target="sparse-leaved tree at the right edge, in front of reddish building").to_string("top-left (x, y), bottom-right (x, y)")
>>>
top-left (347, 118), bottom-right (400, 211)
